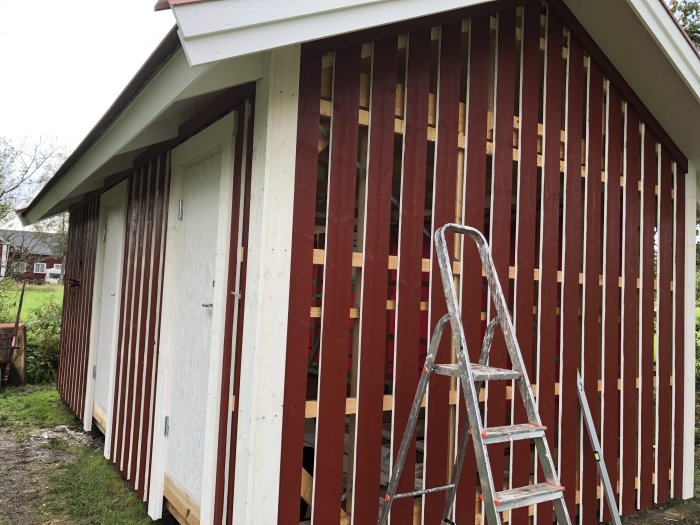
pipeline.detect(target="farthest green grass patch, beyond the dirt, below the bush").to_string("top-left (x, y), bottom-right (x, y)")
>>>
top-left (0, 385), bottom-right (76, 435)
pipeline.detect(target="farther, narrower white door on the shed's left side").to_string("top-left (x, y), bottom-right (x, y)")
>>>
top-left (85, 183), bottom-right (126, 446)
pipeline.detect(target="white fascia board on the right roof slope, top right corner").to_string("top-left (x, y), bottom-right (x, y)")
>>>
top-left (627, 0), bottom-right (700, 101)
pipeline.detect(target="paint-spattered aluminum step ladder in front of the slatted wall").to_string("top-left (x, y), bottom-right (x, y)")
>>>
top-left (378, 224), bottom-right (571, 525)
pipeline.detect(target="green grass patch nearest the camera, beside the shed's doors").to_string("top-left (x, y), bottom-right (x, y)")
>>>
top-left (41, 447), bottom-right (159, 525)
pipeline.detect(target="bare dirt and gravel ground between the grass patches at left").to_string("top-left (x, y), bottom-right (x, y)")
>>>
top-left (0, 425), bottom-right (103, 525)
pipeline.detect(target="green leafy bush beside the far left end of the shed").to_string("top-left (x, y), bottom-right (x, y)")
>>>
top-left (26, 299), bottom-right (63, 383)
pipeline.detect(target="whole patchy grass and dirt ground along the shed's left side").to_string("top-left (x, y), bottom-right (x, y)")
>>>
top-left (0, 386), bottom-right (167, 525)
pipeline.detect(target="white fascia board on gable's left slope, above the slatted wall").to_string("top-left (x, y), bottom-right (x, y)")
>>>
top-left (172, 0), bottom-right (488, 65)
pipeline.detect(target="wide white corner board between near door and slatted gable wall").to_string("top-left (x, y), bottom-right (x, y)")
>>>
top-left (232, 46), bottom-right (300, 523)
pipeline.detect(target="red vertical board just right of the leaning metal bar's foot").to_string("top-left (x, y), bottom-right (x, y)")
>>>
top-left (624, 106), bottom-right (641, 515)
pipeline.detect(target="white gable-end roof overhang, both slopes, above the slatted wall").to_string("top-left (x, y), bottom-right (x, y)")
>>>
top-left (169, 0), bottom-right (700, 161)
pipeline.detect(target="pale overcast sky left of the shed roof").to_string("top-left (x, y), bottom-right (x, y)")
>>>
top-left (0, 0), bottom-right (175, 152)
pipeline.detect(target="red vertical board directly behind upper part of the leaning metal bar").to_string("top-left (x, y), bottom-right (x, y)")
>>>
top-left (581, 61), bottom-right (603, 525)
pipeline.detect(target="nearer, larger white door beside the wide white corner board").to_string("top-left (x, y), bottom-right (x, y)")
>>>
top-left (149, 116), bottom-right (234, 515)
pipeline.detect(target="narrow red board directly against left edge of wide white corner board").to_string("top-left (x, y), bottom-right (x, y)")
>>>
top-left (227, 104), bottom-right (255, 524)
